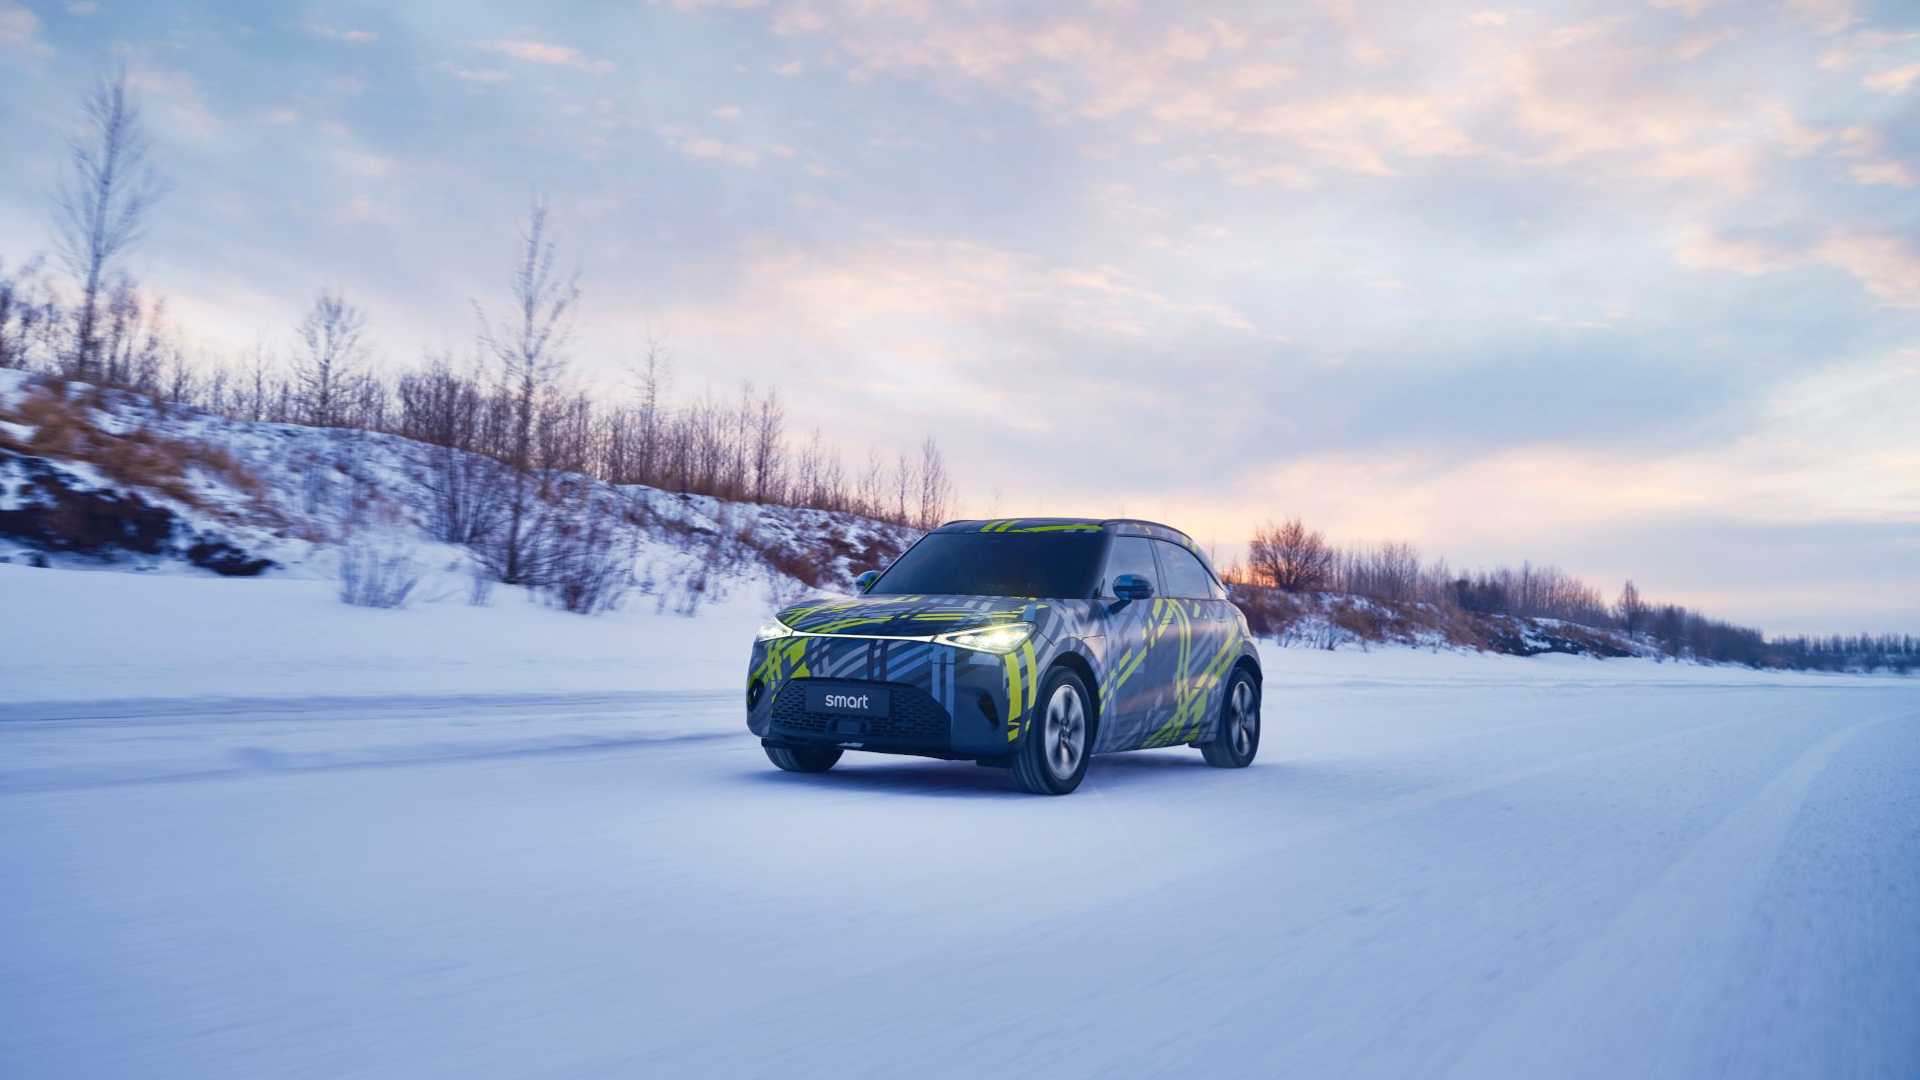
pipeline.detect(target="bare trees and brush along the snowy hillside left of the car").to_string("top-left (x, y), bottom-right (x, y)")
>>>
top-left (0, 71), bottom-right (952, 607)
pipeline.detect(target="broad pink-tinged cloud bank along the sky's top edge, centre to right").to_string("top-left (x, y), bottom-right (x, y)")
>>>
top-left (695, 0), bottom-right (1843, 196)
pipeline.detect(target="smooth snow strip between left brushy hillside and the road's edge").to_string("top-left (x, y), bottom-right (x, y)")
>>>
top-left (0, 565), bottom-right (768, 701)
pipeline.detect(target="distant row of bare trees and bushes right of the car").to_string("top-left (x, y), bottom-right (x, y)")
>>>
top-left (1223, 517), bottom-right (1920, 675)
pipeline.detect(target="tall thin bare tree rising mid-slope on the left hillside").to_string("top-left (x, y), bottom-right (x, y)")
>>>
top-left (474, 200), bottom-right (580, 584)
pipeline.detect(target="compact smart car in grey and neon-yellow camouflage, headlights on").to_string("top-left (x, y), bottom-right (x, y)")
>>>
top-left (747, 517), bottom-right (1261, 796)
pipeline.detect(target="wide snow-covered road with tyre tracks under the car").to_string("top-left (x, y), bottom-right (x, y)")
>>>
top-left (0, 657), bottom-right (1920, 1080)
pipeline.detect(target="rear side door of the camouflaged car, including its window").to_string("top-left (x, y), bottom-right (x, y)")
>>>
top-left (1140, 538), bottom-right (1240, 746)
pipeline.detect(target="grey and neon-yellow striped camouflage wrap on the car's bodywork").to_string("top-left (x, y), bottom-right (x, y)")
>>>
top-left (747, 519), bottom-right (1260, 757)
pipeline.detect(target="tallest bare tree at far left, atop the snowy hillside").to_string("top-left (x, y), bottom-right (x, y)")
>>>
top-left (54, 69), bottom-right (165, 379)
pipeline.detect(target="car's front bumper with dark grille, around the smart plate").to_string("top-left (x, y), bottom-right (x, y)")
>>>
top-left (747, 636), bottom-right (1039, 759)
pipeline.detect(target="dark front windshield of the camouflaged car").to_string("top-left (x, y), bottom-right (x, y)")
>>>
top-left (868, 532), bottom-right (1106, 600)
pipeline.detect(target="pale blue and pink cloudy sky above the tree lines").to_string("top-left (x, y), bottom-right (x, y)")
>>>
top-left (0, 0), bottom-right (1920, 632)
